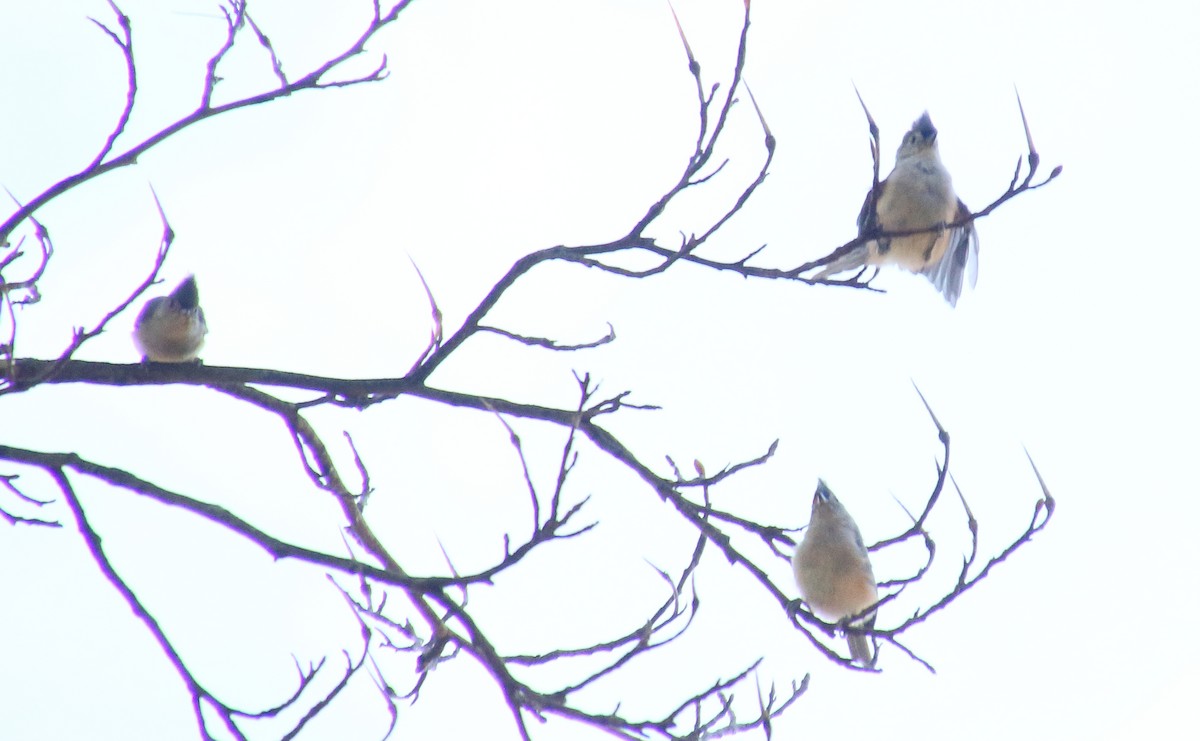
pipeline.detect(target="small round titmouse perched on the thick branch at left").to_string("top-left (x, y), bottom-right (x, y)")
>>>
top-left (133, 276), bottom-right (209, 363)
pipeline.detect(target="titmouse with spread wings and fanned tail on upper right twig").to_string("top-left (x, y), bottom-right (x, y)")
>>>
top-left (815, 112), bottom-right (979, 306)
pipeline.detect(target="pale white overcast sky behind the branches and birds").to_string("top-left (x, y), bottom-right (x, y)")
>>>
top-left (0, 0), bottom-right (1200, 740)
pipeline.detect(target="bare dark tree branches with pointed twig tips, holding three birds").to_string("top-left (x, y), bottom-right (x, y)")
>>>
top-left (0, 0), bottom-right (1061, 740)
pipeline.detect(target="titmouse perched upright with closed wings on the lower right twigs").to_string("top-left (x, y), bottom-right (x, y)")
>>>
top-left (792, 481), bottom-right (878, 667)
